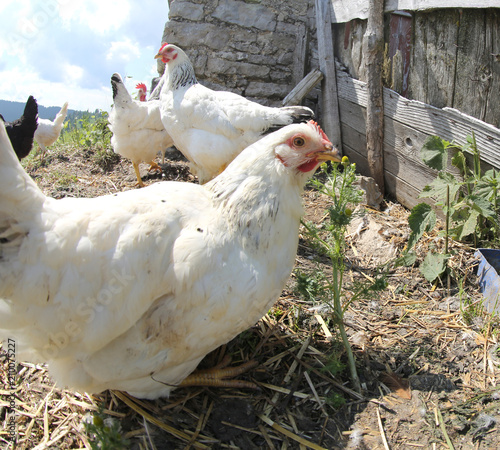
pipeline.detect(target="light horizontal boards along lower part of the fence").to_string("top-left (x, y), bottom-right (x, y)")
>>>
top-left (337, 70), bottom-right (500, 208)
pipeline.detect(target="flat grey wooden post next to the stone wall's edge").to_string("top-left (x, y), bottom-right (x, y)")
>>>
top-left (315, 0), bottom-right (342, 152)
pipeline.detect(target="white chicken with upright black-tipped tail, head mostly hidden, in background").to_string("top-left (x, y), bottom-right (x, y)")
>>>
top-left (108, 73), bottom-right (173, 187)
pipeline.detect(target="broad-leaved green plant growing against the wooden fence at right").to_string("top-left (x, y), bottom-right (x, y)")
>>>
top-left (407, 133), bottom-right (500, 282)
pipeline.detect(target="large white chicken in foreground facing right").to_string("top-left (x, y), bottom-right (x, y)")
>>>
top-left (0, 118), bottom-right (339, 398)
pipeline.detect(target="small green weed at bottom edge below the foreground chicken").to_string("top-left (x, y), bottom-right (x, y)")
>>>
top-left (84, 410), bottom-right (130, 450)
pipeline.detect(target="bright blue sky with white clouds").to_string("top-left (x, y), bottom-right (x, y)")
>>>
top-left (0, 0), bottom-right (168, 112)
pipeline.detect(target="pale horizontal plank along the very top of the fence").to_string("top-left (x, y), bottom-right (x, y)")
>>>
top-left (330, 0), bottom-right (500, 23)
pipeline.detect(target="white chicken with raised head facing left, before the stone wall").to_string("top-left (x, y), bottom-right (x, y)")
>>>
top-left (155, 44), bottom-right (314, 184)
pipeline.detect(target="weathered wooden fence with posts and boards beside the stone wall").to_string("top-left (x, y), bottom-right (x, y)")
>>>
top-left (315, 0), bottom-right (500, 208)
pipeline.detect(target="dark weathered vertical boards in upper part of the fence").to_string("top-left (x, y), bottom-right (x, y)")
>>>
top-left (334, 8), bottom-right (500, 128)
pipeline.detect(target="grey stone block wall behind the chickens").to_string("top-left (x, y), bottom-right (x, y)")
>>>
top-left (158, 0), bottom-right (319, 109)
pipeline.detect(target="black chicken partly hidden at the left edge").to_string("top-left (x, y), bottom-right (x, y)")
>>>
top-left (0, 95), bottom-right (38, 160)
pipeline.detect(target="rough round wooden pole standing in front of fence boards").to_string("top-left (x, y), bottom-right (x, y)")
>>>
top-left (363, 0), bottom-right (384, 193)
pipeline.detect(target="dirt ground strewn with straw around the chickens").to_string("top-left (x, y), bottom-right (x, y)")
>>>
top-left (0, 147), bottom-right (500, 450)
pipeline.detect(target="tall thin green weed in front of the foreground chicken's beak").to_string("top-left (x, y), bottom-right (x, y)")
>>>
top-left (298, 157), bottom-right (386, 392)
